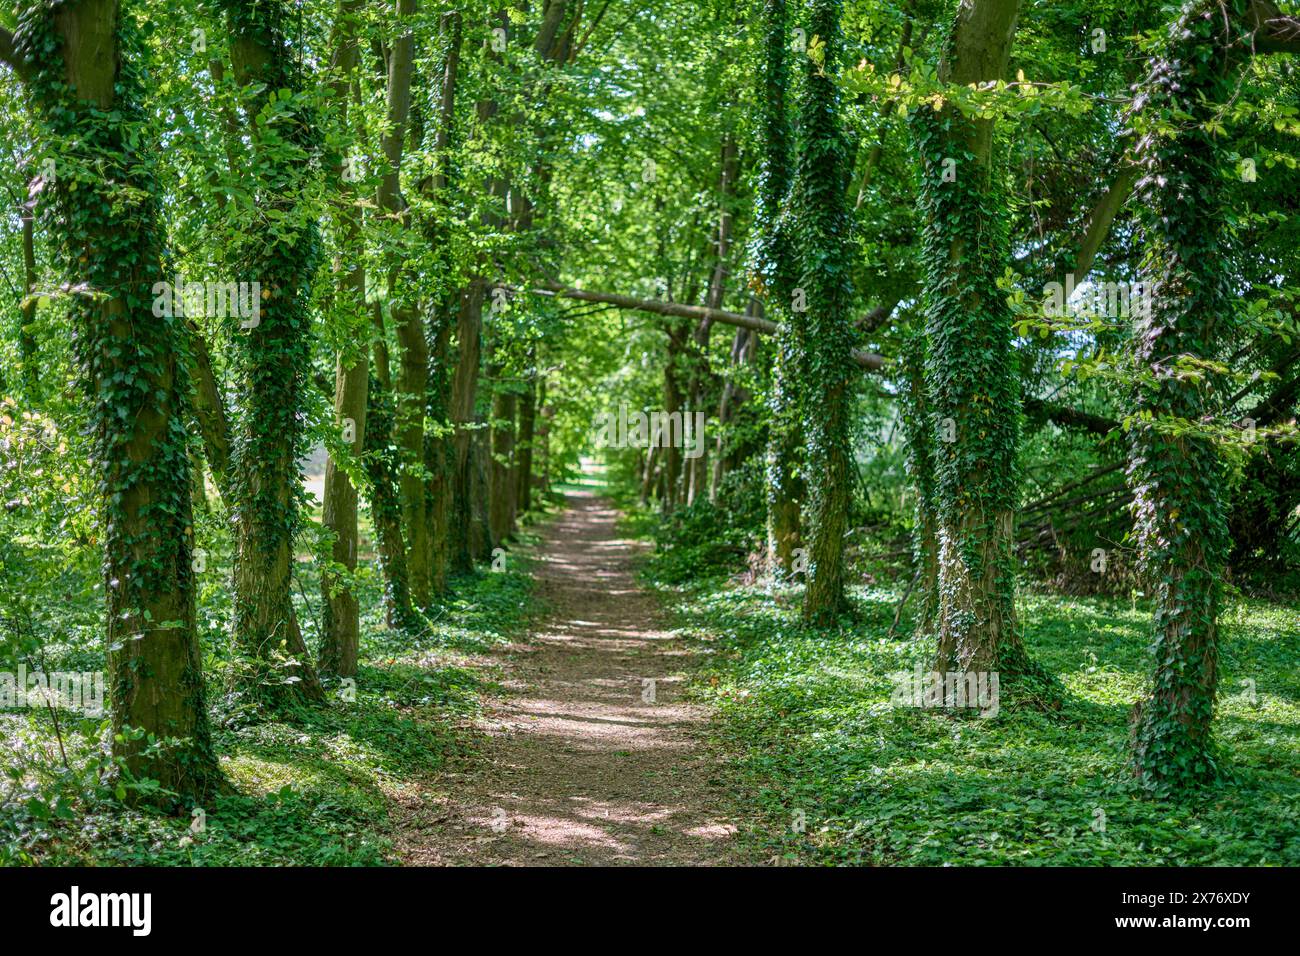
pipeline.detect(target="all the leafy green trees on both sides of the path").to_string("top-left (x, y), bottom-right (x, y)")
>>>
top-left (0, 0), bottom-right (1300, 797)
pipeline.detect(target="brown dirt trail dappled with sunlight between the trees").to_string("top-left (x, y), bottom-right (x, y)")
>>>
top-left (400, 492), bottom-right (745, 866)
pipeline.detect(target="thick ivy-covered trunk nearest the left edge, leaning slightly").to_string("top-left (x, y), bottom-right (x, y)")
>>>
top-left (16, 0), bottom-right (224, 801)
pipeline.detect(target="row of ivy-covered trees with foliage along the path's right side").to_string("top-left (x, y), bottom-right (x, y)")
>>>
top-left (569, 0), bottom-right (1297, 788)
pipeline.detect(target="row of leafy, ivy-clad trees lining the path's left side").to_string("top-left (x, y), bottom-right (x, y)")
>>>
top-left (0, 0), bottom-right (594, 799)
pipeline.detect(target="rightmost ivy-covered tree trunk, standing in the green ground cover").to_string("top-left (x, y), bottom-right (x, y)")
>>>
top-left (1128, 0), bottom-right (1248, 790)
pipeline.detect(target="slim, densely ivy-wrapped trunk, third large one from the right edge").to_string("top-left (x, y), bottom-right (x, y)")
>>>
top-left (789, 0), bottom-right (858, 624)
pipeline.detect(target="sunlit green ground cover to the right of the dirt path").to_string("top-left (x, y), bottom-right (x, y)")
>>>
top-left (650, 563), bottom-right (1300, 866)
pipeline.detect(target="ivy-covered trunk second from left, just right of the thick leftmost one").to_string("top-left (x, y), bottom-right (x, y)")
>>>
top-left (225, 0), bottom-right (324, 704)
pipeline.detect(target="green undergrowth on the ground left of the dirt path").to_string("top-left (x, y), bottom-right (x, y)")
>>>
top-left (0, 554), bottom-right (537, 866)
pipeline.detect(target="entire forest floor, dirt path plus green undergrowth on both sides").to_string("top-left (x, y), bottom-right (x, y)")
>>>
top-left (15, 476), bottom-right (1300, 866)
